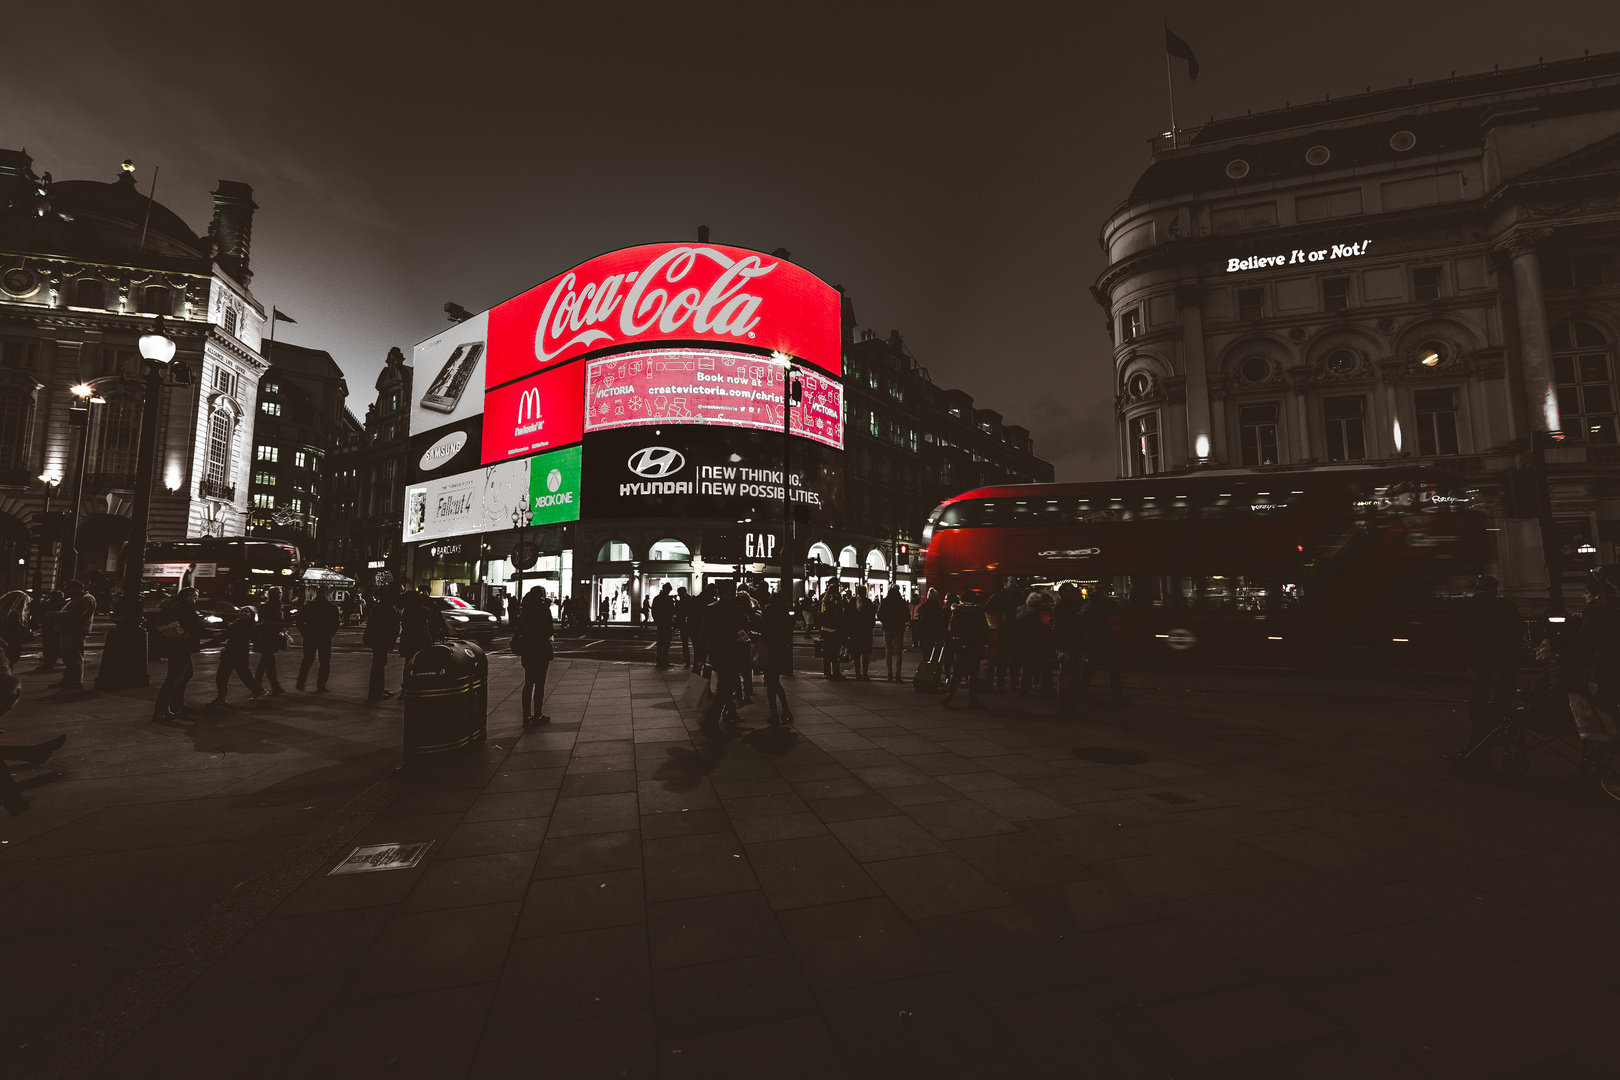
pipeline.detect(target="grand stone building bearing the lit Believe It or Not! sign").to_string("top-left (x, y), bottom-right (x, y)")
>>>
top-left (1094, 53), bottom-right (1620, 608)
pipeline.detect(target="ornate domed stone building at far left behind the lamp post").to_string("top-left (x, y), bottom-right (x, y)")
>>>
top-left (0, 149), bottom-right (266, 588)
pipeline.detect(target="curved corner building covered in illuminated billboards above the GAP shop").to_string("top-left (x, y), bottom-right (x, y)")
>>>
top-left (390, 239), bottom-right (1051, 622)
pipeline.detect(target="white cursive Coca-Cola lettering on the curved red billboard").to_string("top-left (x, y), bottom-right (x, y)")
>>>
top-left (535, 248), bottom-right (779, 364)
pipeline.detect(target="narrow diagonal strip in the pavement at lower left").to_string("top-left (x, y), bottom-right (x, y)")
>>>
top-left (6, 766), bottom-right (413, 1080)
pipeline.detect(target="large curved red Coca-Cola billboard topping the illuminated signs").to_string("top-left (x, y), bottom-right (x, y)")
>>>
top-left (486, 244), bottom-right (841, 387)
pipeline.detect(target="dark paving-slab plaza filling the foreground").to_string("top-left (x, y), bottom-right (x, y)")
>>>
top-left (9, 647), bottom-right (1620, 1078)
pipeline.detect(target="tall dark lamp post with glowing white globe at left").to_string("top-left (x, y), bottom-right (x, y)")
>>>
top-left (96, 316), bottom-right (191, 690)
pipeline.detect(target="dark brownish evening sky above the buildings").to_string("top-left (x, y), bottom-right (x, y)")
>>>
top-left (12, 0), bottom-right (1620, 479)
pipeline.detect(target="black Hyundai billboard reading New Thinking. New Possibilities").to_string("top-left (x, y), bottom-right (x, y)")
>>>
top-left (583, 426), bottom-right (842, 528)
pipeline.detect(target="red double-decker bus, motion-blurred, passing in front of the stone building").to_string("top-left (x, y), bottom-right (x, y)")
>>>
top-left (923, 468), bottom-right (1492, 670)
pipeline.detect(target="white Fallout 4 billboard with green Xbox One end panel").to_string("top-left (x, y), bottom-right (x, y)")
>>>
top-left (403, 445), bottom-right (580, 541)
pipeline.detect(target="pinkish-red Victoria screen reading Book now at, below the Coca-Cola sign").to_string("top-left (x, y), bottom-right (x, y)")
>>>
top-left (585, 348), bottom-right (844, 450)
